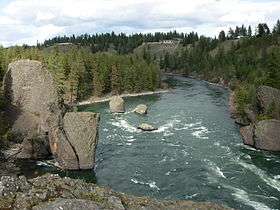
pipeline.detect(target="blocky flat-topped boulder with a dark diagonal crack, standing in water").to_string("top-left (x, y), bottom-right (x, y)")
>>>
top-left (56, 112), bottom-right (100, 169)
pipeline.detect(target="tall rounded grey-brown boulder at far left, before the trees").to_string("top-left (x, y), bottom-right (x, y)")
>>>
top-left (3, 60), bottom-right (63, 159)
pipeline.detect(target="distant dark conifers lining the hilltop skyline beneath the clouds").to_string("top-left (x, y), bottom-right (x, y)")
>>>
top-left (41, 21), bottom-right (280, 54)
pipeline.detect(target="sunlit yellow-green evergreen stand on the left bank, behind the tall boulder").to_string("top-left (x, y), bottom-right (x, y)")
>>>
top-left (0, 47), bottom-right (160, 102)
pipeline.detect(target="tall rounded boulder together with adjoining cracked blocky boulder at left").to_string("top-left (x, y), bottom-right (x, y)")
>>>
top-left (4, 60), bottom-right (99, 169)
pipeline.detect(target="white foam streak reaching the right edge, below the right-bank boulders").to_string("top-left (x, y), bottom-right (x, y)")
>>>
top-left (236, 159), bottom-right (280, 192)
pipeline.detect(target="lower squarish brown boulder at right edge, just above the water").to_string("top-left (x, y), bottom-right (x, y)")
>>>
top-left (255, 120), bottom-right (280, 151)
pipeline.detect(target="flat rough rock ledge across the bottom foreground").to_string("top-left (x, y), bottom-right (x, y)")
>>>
top-left (0, 175), bottom-right (232, 210)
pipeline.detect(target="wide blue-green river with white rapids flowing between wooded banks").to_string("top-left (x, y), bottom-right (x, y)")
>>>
top-left (79, 76), bottom-right (280, 210)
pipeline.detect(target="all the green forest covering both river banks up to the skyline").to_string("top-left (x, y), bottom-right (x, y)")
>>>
top-left (0, 21), bottom-right (280, 120)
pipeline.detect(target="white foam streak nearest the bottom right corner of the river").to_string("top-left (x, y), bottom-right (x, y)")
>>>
top-left (224, 186), bottom-right (271, 210)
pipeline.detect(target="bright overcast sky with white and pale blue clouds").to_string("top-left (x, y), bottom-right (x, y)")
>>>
top-left (0, 0), bottom-right (280, 46)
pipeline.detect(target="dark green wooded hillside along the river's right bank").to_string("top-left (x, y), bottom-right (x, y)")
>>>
top-left (160, 21), bottom-right (280, 118)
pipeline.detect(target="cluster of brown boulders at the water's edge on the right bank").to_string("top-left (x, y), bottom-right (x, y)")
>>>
top-left (229, 86), bottom-right (280, 151)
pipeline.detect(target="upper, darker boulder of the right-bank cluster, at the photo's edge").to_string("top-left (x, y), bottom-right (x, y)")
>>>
top-left (257, 86), bottom-right (280, 119)
